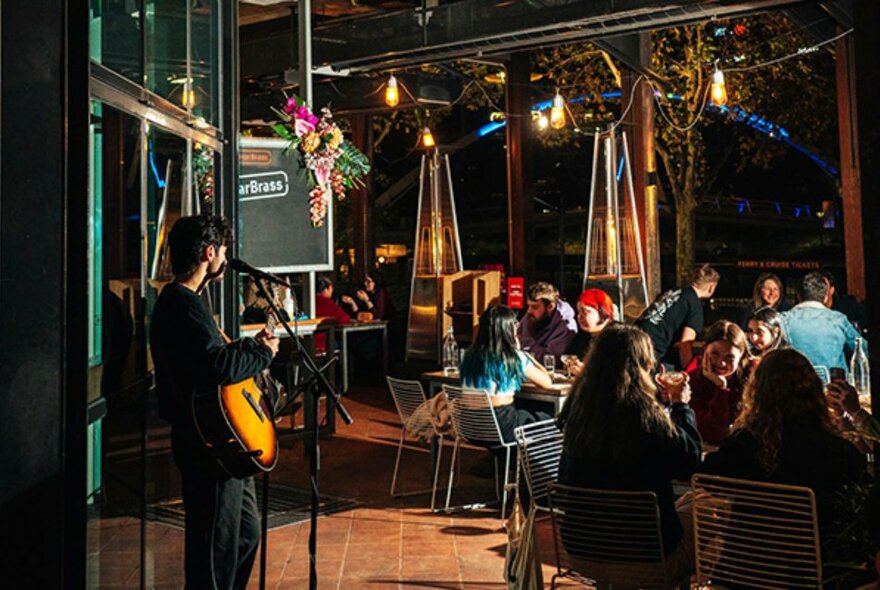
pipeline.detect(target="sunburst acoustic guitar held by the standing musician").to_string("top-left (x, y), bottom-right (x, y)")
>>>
top-left (192, 314), bottom-right (278, 478)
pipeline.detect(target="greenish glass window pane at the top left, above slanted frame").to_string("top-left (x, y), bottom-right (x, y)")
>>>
top-left (89, 0), bottom-right (143, 84)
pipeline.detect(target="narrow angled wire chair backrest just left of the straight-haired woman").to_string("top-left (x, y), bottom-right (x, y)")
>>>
top-left (513, 418), bottom-right (562, 510)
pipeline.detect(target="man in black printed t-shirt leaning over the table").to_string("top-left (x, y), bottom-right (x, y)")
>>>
top-left (635, 264), bottom-right (720, 369)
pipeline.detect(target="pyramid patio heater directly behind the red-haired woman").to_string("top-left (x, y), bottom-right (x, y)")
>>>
top-left (584, 127), bottom-right (649, 321)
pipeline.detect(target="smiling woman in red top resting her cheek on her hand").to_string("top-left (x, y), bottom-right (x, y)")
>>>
top-left (687, 320), bottom-right (749, 445)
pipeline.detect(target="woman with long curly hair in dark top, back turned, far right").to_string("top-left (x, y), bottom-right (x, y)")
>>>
top-left (701, 348), bottom-right (865, 540)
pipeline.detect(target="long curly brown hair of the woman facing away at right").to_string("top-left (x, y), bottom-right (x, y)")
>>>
top-left (734, 348), bottom-right (836, 476)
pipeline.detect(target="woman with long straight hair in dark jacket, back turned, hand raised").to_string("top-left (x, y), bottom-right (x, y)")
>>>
top-left (559, 324), bottom-right (701, 583)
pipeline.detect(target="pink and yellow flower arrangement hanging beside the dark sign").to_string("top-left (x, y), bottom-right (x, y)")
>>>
top-left (272, 95), bottom-right (370, 227)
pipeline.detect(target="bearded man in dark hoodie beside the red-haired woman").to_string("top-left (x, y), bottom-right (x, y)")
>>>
top-left (519, 282), bottom-right (577, 365)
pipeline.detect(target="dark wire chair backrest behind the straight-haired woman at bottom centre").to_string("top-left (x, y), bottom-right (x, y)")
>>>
top-left (548, 483), bottom-right (669, 588)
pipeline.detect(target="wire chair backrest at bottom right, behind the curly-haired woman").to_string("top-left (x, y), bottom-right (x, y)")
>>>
top-left (691, 475), bottom-right (822, 588)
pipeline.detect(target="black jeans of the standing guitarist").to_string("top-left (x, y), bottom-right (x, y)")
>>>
top-left (175, 434), bottom-right (260, 590)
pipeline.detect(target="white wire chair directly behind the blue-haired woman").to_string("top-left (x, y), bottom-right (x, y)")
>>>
top-left (443, 385), bottom-right (516, 520)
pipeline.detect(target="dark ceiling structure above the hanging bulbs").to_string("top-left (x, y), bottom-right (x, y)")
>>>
top-left (239, 0), bottom-right (853, 119)
